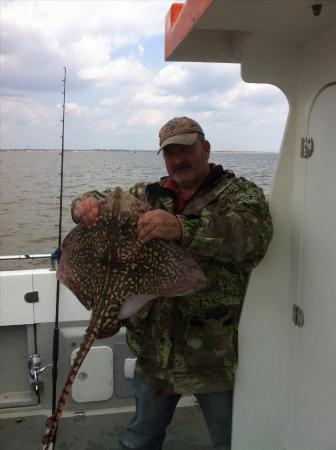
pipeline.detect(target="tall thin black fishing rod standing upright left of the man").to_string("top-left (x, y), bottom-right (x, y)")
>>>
top-left (52, 67), bottom-right (66, 446)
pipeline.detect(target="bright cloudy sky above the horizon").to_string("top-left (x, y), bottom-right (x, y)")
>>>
top-left (0, 0), bottom-right (288, 152)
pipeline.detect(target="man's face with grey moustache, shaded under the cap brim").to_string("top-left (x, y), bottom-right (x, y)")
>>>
top-left (163, 135), bottom-right (210, 189)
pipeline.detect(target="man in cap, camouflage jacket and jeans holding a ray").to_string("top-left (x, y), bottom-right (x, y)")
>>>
top-left (73, 117), bottom-right (272, 450)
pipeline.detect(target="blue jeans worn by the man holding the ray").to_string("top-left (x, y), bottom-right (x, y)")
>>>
top-left (119, 371), bottom-right (233, 450)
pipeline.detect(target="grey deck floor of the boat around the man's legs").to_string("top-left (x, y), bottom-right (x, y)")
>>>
top-left (0, 406), bottom-right (213, 450)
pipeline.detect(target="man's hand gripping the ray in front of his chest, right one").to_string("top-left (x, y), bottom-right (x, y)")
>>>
top-left (138, 209), bottom-right (182, 244)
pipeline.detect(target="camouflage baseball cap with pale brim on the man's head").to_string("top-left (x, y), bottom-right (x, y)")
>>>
top-left (158, 117), bottom-right (204, 153)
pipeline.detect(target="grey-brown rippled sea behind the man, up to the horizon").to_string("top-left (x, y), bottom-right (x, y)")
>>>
top-left (0, 150), bottom-right (278, 270)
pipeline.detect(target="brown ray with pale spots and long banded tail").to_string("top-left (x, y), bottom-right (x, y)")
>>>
top-left (42, 188), bottom-right (206, 450)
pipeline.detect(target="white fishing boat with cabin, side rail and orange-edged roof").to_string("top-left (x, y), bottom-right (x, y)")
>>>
top-left (0, 0), bottom-right (336, 450)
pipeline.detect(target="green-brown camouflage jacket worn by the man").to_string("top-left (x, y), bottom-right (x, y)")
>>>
top-left (71, 166), bottom-right (272, 394)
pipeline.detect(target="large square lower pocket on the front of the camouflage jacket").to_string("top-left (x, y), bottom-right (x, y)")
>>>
top-left (184, 318), bottom-right (237, 369)
